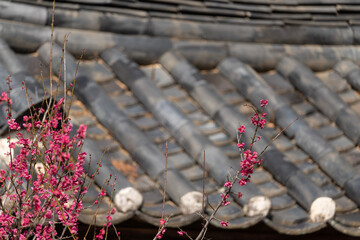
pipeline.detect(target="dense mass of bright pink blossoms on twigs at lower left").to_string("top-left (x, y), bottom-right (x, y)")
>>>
top-left (0, 93), bottom-right (86, 239)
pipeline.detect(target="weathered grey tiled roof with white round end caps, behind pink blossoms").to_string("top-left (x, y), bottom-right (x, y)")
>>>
top-left (0, 0), bottom-right (360, 236)
